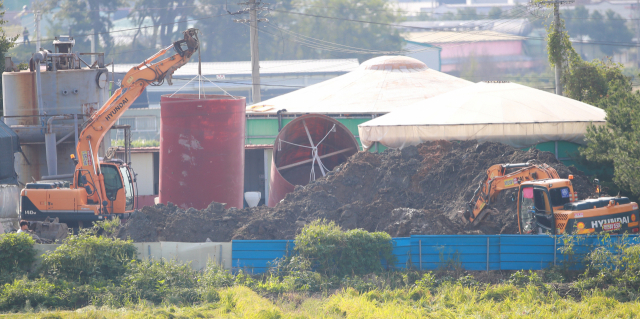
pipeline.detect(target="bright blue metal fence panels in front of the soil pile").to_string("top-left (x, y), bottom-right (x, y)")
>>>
top-left (232, 235), bottom-right (639, 273)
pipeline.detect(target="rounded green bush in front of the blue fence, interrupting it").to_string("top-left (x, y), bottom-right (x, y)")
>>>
top-left (295, 220), bottom-right (395, 277)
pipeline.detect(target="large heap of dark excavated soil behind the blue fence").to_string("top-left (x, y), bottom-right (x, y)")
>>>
top-left (120, 141), bottom-right (593, 242)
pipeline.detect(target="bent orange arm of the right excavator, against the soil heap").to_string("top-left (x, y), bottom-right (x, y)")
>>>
top-left (464, 163), bottom-right (560, 225)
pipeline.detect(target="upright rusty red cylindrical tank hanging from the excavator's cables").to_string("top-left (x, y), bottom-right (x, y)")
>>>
top-left (159, 94), bottom-right (246, 209)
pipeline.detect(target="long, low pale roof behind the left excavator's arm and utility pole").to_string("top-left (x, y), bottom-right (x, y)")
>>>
top-left (115, 58), bottom-right (359, 76)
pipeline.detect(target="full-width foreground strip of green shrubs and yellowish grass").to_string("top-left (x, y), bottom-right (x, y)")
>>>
top-left (0, 222), bottom-right (640, 319)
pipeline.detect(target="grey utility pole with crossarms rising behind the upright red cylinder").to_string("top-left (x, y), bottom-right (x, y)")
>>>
top-left (233, 0), bottom-right (269, 103)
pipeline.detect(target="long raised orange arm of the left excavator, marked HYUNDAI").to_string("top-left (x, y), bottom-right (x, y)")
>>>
top-left (73, 29), bottom-right (199, 210)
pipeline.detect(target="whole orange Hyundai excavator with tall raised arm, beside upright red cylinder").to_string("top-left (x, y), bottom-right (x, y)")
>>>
top-left (20, 29), bottom-right (199, 224)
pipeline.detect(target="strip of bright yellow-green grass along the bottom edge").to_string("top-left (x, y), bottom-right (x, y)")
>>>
top-left (0, 284), bottom-right (640, 318)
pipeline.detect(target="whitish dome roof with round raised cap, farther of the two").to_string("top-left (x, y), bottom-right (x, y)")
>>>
top-left (247, 56), bottom-right (473, 115)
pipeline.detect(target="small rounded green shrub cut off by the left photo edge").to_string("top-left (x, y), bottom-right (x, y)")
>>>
top-left (0, 233), bottom-right (36, 274)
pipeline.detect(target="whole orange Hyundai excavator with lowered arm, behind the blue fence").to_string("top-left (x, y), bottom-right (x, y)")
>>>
top-left (464, 163), bottom-right (640, 234)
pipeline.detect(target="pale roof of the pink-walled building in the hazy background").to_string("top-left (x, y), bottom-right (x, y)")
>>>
top-left (403, 31), bottom-right (526, 45)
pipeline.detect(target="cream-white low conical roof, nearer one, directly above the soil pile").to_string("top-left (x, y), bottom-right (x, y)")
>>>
top-left (358, 82), bottom-right (606, 150)
